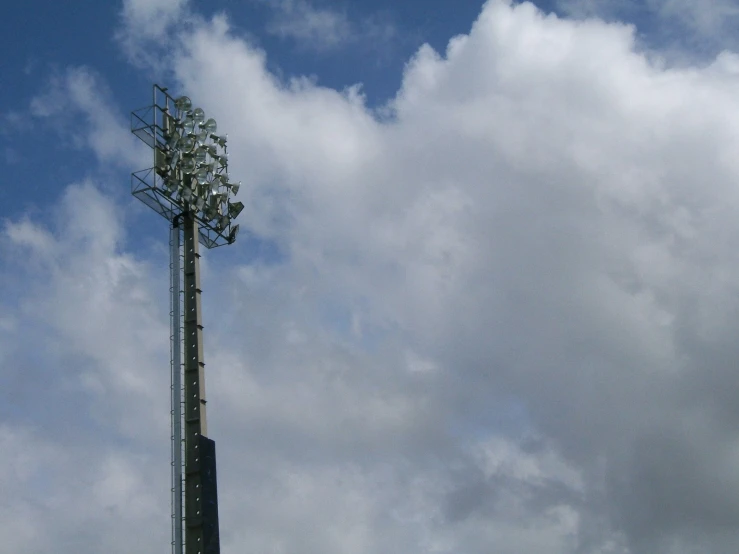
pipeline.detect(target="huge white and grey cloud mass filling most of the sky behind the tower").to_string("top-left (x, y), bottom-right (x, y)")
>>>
top-left (7, 1), bottom-right (739, 554)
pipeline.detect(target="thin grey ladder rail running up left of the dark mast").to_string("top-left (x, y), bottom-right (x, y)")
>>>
top-left (169, 219), bottom-right (183, 554)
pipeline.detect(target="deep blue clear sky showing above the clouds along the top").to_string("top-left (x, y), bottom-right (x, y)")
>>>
top-left (0, 0), bottom-right (719, 221)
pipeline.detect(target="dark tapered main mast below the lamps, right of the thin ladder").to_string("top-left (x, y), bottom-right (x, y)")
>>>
top-left (182, 211), bottom-right (208, 554)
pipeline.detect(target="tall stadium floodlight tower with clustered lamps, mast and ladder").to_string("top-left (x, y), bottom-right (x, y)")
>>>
top-left (131, 85), bottom-right (244, 554)
